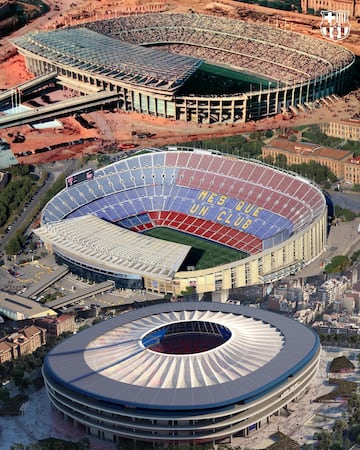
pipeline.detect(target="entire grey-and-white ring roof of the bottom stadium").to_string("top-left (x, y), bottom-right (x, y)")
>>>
top-left (44, 302), bottom-right (319, 410)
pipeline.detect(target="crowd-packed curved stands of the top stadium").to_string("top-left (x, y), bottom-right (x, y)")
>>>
top-left (85, 14), bottom-right (353, 83)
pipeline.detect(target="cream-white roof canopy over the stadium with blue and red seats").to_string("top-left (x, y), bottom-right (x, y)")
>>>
top-left (34, 214), bottom-right (191, 281)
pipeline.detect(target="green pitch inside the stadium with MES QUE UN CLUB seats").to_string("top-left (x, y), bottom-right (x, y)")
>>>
top-left (145, 227), bottom-right (247, 270)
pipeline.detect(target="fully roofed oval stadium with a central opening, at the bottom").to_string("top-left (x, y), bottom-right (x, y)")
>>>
top-left (43, 302), bottom-right (321, 448)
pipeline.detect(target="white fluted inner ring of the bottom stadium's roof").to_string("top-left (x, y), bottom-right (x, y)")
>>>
top-left (84, 310), bottom-right (284, 389)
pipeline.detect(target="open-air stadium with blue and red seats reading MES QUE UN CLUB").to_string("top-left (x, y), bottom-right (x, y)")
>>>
top-left (34, 148), bottom-right (327, 299)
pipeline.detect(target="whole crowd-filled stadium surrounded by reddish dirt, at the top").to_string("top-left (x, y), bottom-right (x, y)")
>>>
top-left (11, 13), bottom-right (355, 124)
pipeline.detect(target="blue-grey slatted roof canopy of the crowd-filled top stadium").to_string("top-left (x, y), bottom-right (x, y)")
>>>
top-left (11, 28), bottom-right (203, 91)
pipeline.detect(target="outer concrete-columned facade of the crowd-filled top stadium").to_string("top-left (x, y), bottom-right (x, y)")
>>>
top-left (11, 14), bottom-right (355, 124)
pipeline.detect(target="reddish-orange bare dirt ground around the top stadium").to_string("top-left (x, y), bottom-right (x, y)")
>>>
top-left (0, 0), bottom-right (360, 164)
